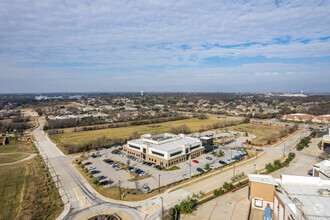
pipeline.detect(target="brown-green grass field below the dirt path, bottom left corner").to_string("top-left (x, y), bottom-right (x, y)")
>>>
top-left (0, 157), bottom-right (63, 219)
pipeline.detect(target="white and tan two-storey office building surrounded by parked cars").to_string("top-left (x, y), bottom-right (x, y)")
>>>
top-left (123, 133), bottom-right (204, 167)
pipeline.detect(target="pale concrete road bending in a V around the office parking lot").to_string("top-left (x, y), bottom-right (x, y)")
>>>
top-left (32, 119), bottom-right (310, 220)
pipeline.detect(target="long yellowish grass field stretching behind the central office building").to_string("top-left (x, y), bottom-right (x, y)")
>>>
top-left (55, 118), bottom-right (229, 145)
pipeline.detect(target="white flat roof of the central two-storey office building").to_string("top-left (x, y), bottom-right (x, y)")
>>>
top-left (129, 133), bottom-right (201, 151)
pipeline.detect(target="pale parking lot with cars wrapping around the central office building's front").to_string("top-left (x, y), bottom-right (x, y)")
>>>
top-left (84, 133), bottom-right (251, 192)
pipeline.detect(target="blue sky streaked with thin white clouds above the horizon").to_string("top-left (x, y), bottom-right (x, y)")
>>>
top-left (0, 0), bottom-right (330, 93)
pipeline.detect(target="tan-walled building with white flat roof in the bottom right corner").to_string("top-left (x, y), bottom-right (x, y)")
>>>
top-left (248, 174), bottom-right (330, 220)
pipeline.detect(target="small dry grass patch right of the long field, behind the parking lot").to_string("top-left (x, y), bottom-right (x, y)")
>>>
top-left (229, 124), bottom-right (287, 145)
